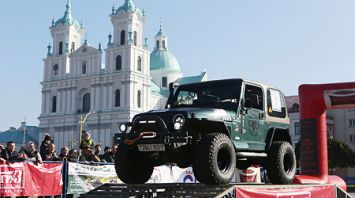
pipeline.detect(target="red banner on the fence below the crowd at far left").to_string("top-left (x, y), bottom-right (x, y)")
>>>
top-left (0, 163), bottom-right (63, 197)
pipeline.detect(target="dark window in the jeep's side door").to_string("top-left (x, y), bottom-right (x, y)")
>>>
top-left (244, 85), bottom-right (264, 110)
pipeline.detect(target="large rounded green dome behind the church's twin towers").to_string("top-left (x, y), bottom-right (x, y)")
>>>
top-left (150, 49), bottom-right (181, 72)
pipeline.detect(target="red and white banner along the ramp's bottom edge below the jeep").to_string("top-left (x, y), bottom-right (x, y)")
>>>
top-left (236, 185), bottom-right (335, 198)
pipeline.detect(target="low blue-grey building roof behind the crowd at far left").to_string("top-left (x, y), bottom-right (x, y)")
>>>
top-left (0, 126), bottom-right (40, 145)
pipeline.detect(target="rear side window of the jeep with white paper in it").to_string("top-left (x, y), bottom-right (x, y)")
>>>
top-left (267, 89), bottom-right (286, 118)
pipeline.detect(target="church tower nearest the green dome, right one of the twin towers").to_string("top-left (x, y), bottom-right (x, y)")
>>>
top-left (105, 0), bottom-right (151, 120)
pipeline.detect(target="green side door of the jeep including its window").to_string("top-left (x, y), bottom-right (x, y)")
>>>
top-left (238, 84), bottom-right (266, 151)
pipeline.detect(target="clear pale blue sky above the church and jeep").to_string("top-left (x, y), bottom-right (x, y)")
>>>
top-left (0, 0), bottom-right (355, 131)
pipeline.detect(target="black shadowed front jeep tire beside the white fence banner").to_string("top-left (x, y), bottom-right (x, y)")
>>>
top-left (115, 144), bottom-right (154, 184)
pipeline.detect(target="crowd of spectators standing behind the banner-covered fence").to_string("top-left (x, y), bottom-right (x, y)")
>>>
top-left (0, 132), bottom-right (117, 164)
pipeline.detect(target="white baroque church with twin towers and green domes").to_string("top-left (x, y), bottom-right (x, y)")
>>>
top-left (38, 0), bottom-right (208, 149)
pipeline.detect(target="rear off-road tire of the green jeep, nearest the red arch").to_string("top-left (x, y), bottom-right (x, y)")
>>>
top-left (265, 141), bottom-right (296, 184)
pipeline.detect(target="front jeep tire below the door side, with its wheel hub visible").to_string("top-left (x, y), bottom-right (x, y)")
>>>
top-left (193, 133), bottom-right (236, 184)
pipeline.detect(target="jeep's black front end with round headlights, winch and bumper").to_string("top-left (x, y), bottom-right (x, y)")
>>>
top-left (119, 114), bottom-right (192, 152)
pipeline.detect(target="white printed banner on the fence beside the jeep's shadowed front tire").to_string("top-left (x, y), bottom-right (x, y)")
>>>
top-left (67, 162), bottom-right (122, 194)
